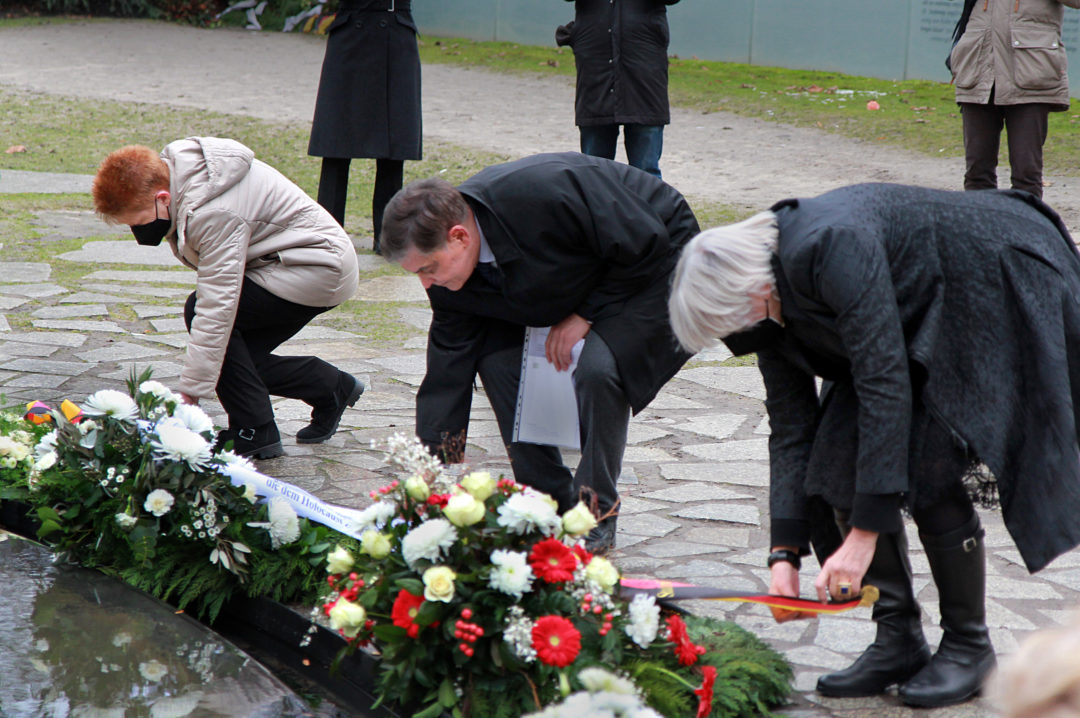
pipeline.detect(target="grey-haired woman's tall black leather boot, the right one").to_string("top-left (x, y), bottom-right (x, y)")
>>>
top-left (900, 515), bottom-right (997, 708)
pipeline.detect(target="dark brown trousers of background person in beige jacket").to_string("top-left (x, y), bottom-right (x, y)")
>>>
top-left (960, 99), bottom-right (1050, 198)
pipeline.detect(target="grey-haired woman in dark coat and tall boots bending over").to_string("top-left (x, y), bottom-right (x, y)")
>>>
top-left (670, 185), bottom-right (1080, 707)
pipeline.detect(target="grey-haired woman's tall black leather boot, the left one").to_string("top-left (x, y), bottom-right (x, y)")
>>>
top-left (818, 530), bottom-right (930, 697)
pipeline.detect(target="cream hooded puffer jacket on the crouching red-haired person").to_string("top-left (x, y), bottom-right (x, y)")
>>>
top-left (161, 137), bottom-right (359, 397)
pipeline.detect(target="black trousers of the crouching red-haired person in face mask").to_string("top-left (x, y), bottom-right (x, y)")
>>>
top-left (184, 276), bottom-right (341, 429)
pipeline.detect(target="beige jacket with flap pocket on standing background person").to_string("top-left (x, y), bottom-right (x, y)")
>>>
top-left (950, 0), bottom-right (1080, 110)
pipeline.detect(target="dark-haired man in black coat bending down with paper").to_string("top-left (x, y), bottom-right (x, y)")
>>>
top-left (382, 152), bottom-right (698, 551)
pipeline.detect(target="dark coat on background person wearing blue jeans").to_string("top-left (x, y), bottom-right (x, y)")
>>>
top-left (555, 0), bottom-right (678, 126)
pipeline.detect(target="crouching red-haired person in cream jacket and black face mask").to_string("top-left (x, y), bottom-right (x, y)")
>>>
top-left (93, 137), bottom-right (364, 459)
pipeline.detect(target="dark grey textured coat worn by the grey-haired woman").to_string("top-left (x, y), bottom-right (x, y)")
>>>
top-left (758, 185), bottom-right (1080, 571)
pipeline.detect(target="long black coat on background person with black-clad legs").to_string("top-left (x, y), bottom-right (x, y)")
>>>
top-left (308, 0), bottom-right (421, 160)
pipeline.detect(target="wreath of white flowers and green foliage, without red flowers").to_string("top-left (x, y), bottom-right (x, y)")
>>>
top-left (0, 371), bottom-right (355, 620)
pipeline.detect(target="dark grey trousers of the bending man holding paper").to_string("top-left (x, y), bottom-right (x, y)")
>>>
top-left (480, 333), bottom-right (630, 513)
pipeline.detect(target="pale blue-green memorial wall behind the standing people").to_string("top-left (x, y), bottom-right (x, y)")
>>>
top-left (413, 0), bottom-right (1080, 95)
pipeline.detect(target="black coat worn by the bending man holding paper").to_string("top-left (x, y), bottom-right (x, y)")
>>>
top-left (416, 152), bottom-right (698, 445)
